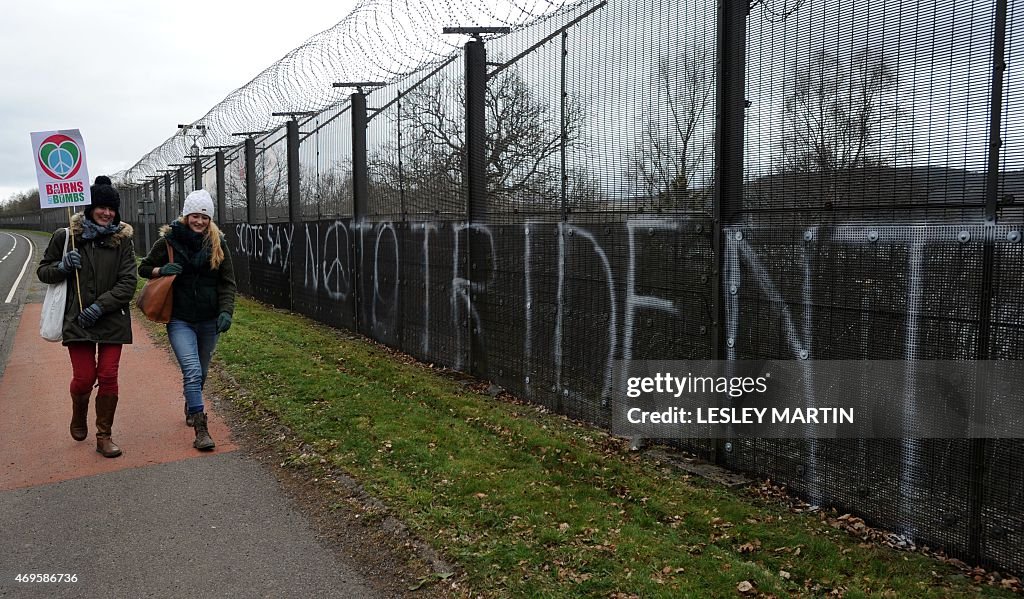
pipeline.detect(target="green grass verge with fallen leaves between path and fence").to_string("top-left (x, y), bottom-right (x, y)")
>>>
top-left (207, 298), bottom-right (1015, 598)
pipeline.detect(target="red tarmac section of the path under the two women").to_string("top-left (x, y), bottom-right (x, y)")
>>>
top-left (0, 303), bottom-right (238, 491)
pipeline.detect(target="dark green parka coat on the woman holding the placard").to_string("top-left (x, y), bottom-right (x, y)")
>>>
top-left (36, 212), bottom-right (138, 345)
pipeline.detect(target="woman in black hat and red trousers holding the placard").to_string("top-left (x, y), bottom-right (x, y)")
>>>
top-left (36, 175), bottom-right (137, 458)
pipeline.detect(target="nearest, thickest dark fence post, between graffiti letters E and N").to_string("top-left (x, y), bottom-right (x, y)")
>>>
top-left (711, 0), bottom-right (750, 464)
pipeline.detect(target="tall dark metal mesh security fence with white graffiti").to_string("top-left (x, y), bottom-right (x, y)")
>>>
top-left (4, 0), bottom-right (1024, 572)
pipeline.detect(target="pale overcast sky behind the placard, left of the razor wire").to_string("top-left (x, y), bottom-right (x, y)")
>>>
top-left (0, 0), bottom-right (356, 202)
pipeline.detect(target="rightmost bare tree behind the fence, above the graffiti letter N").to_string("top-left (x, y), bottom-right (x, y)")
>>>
top-left (782, 49), bottom-right (909, 173)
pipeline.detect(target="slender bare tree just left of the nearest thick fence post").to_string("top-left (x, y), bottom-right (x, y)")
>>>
top-left (627, 51), bottom-right (713, 209)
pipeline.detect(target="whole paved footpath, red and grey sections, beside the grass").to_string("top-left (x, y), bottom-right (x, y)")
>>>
top-left (0, 303), bottom-right (378, 598)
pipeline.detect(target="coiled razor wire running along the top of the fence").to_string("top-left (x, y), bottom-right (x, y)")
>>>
top-left (114, 0), bottom-right (595, 184)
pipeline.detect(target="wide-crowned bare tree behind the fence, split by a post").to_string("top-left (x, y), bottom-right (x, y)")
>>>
top-left (370, 68), bottom-right (598, 212)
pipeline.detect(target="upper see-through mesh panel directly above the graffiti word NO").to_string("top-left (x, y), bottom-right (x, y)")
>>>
top-left (299, 103), bottom-right (352, 220)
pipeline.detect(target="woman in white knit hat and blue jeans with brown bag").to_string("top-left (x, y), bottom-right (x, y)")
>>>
top-left (138, 189), bottom-right (236, 451)
